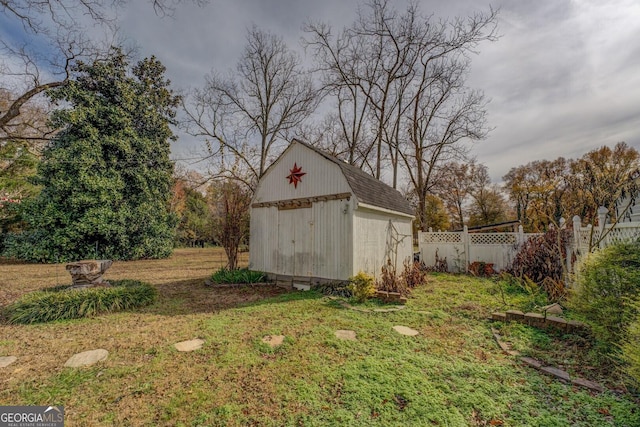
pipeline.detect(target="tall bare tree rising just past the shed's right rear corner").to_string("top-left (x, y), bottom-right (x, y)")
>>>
top-left (399, 10), bottom-right (497, 231)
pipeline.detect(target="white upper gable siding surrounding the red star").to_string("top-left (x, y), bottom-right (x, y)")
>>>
top-left (253, 144), bottom-right (351, 203)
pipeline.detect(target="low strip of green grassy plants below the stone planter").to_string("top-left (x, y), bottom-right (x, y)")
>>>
top-left (3, 280), bottom-right (157, 324)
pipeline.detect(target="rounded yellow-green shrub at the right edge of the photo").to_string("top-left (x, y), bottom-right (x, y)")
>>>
top-left (568, 242), bottom-right (640, 344)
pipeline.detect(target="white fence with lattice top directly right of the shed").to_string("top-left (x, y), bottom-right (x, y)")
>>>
top-left (418, 226), bottom-right (537, 273)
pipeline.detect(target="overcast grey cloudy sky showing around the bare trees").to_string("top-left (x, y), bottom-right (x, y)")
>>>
top-left (5, 0), bottom-right (640, 182)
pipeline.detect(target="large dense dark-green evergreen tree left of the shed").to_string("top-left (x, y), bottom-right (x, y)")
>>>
top-left (5, 48), bottom-right (179, 262)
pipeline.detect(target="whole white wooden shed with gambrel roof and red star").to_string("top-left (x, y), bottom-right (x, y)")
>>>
top-left (249, 140), bottom-right (413, 289)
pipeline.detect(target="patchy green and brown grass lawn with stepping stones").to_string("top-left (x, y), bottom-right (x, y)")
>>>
top-left (0, 249), bottom-right (640, 427)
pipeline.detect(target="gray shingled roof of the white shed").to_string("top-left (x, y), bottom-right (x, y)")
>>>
top-left (293, 139), bottom-right (414, 215)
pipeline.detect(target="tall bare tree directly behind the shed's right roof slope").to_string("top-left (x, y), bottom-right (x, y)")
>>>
top-left (305, 0), bottom-right (421, 182)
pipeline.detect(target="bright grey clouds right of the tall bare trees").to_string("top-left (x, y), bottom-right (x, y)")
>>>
top-left (471, 0), bottom-right (640, 180)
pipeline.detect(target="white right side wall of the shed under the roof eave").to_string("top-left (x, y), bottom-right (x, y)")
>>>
top-left (352, 208), bottom-right (413, 278)
